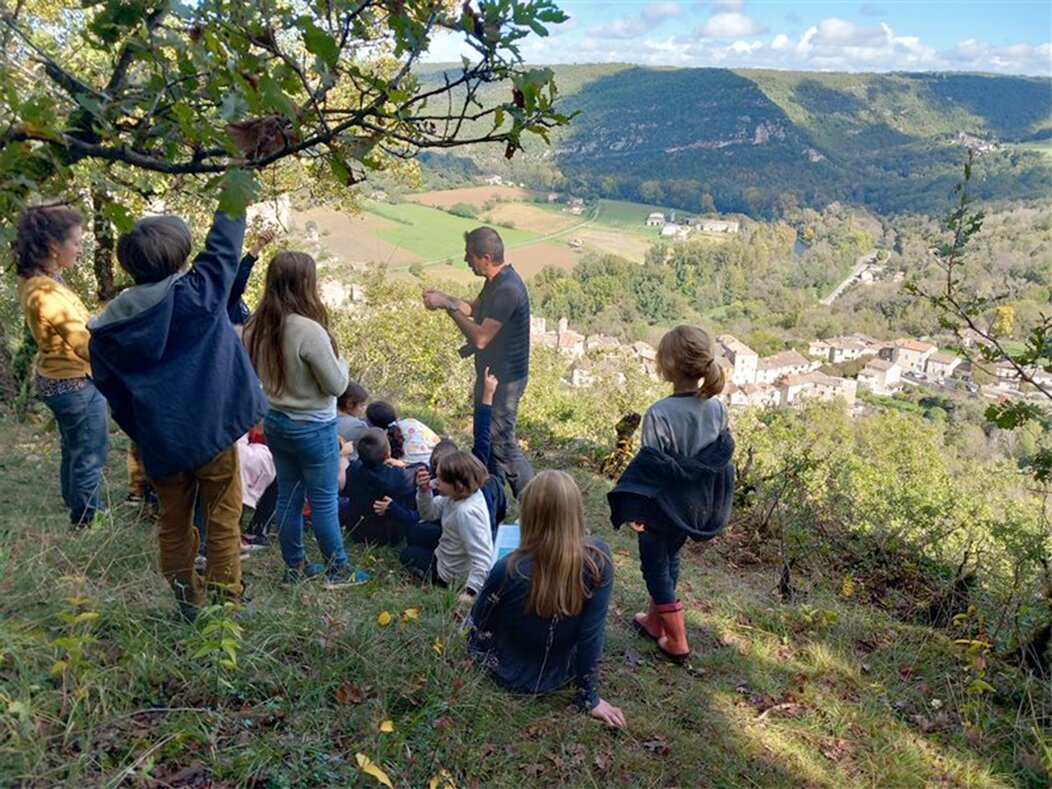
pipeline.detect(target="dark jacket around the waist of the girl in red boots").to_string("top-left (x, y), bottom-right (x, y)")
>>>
top-left (607, 429), bottom-right (734, 541)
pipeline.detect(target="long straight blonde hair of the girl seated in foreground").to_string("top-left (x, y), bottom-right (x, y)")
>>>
top-left (508, 470), bottom-right (604, 619)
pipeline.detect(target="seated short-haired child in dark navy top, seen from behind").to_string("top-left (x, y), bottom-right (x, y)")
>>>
top-left (342, 427), bottom-right (418, 545)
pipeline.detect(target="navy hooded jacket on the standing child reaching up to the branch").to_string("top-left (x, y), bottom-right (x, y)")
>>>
top-left (88, 214), bottom-right (267, 478)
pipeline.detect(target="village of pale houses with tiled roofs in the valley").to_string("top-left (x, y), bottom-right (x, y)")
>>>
top-left (530, 317), bottom-right (1052, 412)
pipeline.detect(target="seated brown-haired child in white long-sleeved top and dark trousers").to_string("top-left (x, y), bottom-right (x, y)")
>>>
top-left (402, 451), bottom-right (493, 600)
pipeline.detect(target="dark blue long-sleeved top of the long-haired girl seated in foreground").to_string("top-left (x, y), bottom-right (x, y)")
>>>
top-left (468, 538), bottom-right (613, 710)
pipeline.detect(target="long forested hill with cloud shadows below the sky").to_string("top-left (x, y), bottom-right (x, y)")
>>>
top-left (422, 65), bottom-right (1052, 215)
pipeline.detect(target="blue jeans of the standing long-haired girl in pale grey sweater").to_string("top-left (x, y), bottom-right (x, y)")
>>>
top-left (263, 410), bottom-right (347, 567)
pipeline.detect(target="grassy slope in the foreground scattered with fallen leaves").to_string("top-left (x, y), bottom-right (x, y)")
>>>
top-left (0, 422), bottom-right (1046, 787)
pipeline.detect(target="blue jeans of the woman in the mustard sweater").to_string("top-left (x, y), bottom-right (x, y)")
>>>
top-left (41, 381), bottom-right (109, 524)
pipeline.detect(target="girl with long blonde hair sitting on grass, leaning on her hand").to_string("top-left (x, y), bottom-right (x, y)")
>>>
top-left (468, 471), bottom-right (625, 728)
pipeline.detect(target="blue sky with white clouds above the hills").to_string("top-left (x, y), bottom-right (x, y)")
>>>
top-left (427, 0), bottom-right (1052, 77)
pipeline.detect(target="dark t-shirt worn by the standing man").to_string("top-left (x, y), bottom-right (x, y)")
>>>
top-left (471, 265), bottom-right (529, 383)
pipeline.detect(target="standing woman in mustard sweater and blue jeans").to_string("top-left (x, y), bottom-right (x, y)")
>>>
top-left (15, 205), bottom-right (109, 526)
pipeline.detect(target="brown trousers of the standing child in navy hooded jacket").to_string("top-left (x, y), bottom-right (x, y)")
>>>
top-left (150, 444), bottom-right (242, 605)
